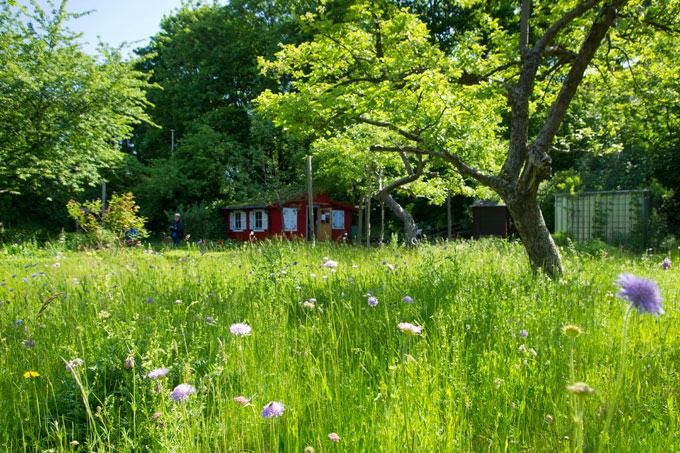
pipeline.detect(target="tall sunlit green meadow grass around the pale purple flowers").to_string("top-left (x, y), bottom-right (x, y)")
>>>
top-left (0, 240), bottom-right (680, 452)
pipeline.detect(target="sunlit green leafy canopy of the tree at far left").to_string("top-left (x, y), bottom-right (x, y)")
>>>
top-left (0, 1), bottom-right (149, 194)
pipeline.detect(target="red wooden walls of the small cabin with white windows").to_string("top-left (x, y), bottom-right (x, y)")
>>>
top-left (222, 194), bottom-right (356, 241)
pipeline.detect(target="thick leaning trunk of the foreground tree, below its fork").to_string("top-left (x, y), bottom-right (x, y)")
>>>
top-left (505, 195), bottom-right (563, 279)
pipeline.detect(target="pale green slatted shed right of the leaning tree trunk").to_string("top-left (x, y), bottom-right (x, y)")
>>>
top-left (555, 190), bottom-right (651, 243)
